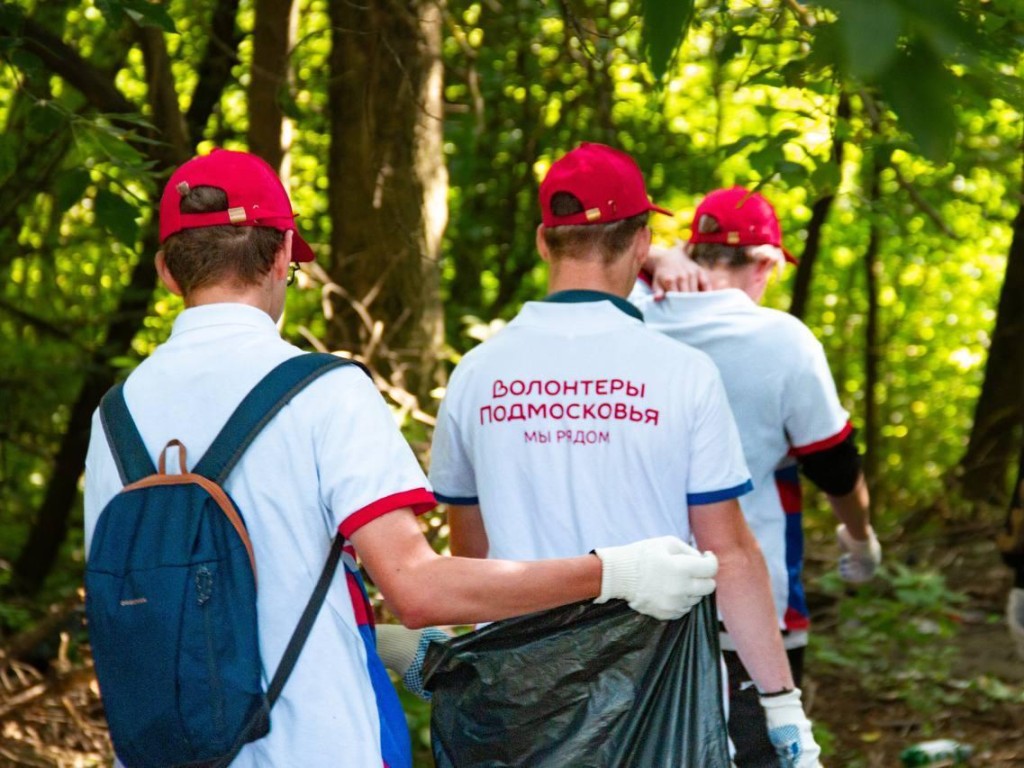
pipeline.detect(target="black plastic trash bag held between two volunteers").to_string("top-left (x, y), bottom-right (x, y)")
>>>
top-left (423, 595), bottom-right (729, 768)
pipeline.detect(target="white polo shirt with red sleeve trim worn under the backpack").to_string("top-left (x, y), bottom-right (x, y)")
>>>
top-left (85, 304), bottom-right (434, 768)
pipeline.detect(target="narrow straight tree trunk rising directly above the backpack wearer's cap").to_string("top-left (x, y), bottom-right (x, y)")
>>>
top-left (249, 0), bottom-right (298, 168)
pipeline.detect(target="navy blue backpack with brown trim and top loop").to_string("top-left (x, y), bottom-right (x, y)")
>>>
top-left (85, 354), bottom-right (357, 768)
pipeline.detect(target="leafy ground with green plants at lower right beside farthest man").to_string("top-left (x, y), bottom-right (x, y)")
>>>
top-left (805, 525), bottom-right (1024, 768)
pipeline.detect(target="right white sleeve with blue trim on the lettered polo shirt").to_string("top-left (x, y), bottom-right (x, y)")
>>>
top-left (686, 365), bottom-right (754, 505)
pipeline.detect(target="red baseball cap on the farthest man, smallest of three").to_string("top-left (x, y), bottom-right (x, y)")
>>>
top-left (690, 186), bottom-right (797, 264)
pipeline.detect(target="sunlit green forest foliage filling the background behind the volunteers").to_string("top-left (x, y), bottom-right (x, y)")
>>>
top-left (0, 0), bottom-right (1024, 761)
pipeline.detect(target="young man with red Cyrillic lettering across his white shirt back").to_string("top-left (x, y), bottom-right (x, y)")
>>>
top-left (430, 143), bottom-right (819, 768)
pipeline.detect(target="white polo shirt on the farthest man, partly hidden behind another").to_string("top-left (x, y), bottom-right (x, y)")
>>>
top-left (630, 281), bottom-right (852, 647)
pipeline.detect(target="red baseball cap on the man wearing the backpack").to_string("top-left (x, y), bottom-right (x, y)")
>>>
top-left (160, 148), bottom-right (315, 261)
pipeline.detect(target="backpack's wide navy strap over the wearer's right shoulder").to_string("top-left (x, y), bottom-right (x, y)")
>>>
top-left (193, 352), bottom-right (370, 485)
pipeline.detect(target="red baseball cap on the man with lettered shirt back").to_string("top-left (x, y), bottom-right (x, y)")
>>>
top-left (540, 142), bottom-right (672, 226)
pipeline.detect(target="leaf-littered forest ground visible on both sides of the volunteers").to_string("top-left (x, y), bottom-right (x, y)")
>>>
top-left (0, 525), bottom-right (1024, 768)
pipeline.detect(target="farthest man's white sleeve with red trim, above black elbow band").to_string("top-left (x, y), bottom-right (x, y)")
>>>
top-left (782, 327), bottom-right (852, 456)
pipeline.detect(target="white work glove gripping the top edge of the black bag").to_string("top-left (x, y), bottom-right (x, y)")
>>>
top-left (594, 536), bottom-right (718, 622)
